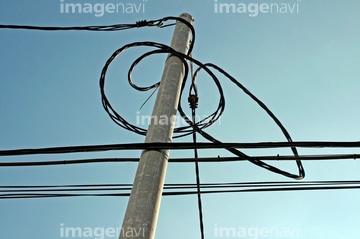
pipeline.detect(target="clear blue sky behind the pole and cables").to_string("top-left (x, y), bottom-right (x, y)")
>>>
top-left (0, 0), bottom-right (360, 239)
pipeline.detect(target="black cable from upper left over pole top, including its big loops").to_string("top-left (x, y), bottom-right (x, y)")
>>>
top-left (83, 11), bottom-right (305, 179)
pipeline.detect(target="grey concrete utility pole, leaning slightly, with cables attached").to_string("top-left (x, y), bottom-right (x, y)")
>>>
top-left (119, 14), bottom-right (193, 239)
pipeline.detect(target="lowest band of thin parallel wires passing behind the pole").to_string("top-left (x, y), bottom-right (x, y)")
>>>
top-left (0, 180), bottom-right (360, 199)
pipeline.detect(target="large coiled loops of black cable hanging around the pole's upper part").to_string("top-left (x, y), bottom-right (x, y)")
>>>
top-left (100, 42), bottom-right (305, 179)
